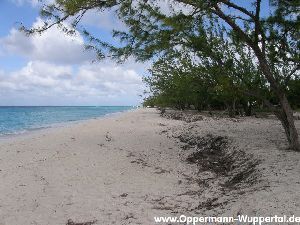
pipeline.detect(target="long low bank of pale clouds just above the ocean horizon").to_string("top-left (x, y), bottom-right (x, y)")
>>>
top-left (0, 61), bottom-right (144, 105)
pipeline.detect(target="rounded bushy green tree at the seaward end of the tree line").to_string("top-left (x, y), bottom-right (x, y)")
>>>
top-left (145, 54), bottom-right (214, 110)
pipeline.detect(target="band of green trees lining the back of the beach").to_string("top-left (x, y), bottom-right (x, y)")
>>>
top-left (143, 43), bottom-right (300, 117)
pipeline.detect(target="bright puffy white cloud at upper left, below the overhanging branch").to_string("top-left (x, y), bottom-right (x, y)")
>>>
top-left (0, 19), bottom-right (95, 64)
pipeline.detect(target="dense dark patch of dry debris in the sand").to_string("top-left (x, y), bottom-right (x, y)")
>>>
top-left (178, 133), bottom-right (259, 188)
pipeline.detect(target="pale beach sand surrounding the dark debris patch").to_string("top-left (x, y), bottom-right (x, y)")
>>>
top-left (0, 109), bottom-right (300, 225)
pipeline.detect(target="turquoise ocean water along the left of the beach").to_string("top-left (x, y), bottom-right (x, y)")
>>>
top-left (0, 106), bottom-right (134, 136)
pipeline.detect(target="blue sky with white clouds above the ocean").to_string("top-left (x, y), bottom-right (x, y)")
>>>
top-left (0, 0), bottom-right (149, 106)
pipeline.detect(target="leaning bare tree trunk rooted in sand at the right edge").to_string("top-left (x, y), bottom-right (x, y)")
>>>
top-left (254, 49), bottom-right (300, 151)
